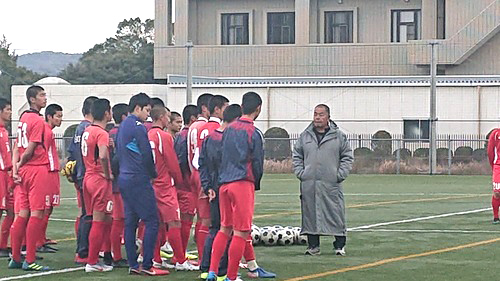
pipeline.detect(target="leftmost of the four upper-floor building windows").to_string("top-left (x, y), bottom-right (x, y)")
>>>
top-left (221, 13), bottom-right (249, 45)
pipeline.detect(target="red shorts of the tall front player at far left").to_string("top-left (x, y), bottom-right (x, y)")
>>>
top-left (15, 165), bottom-right (51, 211)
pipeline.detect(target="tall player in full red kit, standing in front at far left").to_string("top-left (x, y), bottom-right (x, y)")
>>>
top-left (9, 86), bottom-right (50, 271)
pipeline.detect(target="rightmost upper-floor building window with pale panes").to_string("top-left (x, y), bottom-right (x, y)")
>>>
top-left (391, 10), bottom-right (421, 42)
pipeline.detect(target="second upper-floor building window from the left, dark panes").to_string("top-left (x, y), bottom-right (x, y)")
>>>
top-left (267, 12), bottom-right (295, 44)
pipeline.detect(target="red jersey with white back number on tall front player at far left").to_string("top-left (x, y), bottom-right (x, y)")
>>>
top-left (17, 110), bottom-right (49, 166)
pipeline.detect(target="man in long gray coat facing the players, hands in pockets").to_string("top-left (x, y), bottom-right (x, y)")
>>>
top-left (293, 104), bottom-right (354, 255)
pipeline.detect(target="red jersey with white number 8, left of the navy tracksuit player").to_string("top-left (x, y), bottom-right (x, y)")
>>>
top-left (81, 125), bottom-right (111, 175)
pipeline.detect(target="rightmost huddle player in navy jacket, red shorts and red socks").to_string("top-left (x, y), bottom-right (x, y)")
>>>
top-left (207, 92), bottom-right (264, 281)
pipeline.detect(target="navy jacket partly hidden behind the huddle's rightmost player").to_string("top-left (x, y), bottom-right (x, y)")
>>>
top-left (198, 130), bottom-right (222, 194)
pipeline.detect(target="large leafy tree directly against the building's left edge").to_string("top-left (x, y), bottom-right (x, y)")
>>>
top-left (60, 18), bottom-right (154, 84)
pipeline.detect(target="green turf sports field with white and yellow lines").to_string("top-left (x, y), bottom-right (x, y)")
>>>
top-left (0, 175), bottom-right (500, 281)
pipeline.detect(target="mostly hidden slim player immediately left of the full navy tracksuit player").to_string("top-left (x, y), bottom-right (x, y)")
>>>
top-left (105, 103), bottom-right (128, 268)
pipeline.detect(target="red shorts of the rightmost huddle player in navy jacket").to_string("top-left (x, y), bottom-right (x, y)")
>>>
top-left (219, 181), bottom-right (255, 231)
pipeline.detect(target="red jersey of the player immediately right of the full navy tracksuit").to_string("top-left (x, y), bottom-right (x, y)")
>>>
top-left (148, 127), bottom-right (183, 189)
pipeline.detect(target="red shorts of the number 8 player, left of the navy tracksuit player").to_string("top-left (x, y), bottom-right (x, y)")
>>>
top-left (83, 174), bottom-right (113, 215)
